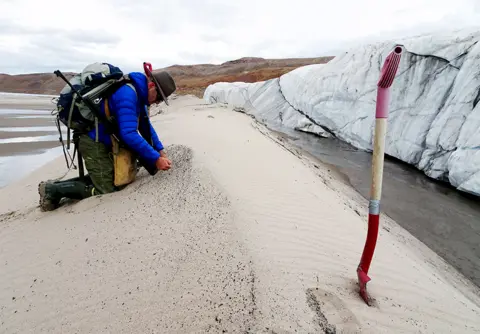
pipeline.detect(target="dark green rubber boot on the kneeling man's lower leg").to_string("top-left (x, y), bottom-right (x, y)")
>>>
top-left (38, 179), bottom-right (97, 211)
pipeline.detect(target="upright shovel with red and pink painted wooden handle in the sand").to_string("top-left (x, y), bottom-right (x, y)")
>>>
top-left (357, 46), bottom-right (402, 305)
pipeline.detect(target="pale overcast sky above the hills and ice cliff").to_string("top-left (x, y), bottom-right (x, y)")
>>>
top-left (0, 0), bottom-right (480, 74)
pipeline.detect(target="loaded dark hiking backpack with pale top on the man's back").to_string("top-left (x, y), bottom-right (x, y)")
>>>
top-left (56, 63), bottom-right (133, 133)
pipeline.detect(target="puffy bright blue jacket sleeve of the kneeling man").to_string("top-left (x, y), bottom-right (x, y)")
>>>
top-left (111, 86), bottom-right (160, 165)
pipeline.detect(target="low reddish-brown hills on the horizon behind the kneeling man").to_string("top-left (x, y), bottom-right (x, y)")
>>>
top-left (0, 57), bottom-right (333, 97)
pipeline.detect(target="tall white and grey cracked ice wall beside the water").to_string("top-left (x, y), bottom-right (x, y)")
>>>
top-left (204, 30), bottom-right (480, 196)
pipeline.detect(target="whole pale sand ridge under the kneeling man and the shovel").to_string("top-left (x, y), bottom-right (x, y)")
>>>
top-left (0, 97), bottom-right (480, 333)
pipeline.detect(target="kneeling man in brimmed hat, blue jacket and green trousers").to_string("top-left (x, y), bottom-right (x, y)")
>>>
top-left (38, 72), bottom-right (176, 211)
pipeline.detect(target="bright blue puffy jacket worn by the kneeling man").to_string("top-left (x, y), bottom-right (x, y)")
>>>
top-left (88, 72), bottom-right (163, 166)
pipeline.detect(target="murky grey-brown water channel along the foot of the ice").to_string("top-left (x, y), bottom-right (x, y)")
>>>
top-left (270, 121), bottom-right (480, 287)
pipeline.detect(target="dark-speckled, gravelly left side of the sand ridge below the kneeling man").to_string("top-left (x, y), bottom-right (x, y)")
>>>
top-left (0, 146), bottom-right (255, 333)
